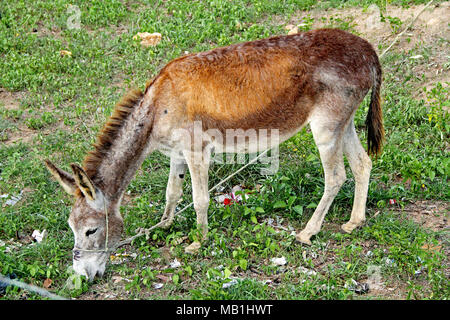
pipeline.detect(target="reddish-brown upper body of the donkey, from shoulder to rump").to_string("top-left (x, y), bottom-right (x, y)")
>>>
top-left (161, 29), bottom-right (381, 134)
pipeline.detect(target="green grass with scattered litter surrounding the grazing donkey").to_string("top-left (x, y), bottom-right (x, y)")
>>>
top-left (0, 0), bottom-right (450, 299)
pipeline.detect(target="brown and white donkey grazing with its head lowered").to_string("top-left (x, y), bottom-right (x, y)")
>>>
top-left (45, 29), bottom-right (384, 280)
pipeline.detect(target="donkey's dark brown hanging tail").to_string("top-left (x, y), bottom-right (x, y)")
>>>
top-left (366, 58), bottom-right (384, 156)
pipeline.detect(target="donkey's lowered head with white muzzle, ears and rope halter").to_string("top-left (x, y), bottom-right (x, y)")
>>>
top-left (45, 160), bottom-right (123, 280)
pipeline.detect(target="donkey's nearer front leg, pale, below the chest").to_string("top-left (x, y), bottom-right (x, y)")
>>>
top-left (184, 147), bottom-right (211, 250)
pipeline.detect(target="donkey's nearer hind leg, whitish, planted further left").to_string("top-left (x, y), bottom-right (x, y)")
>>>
top-left (296, 120), bottom-right (346, 245)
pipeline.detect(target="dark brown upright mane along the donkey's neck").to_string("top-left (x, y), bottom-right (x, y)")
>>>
top-left (83, 89), bottom-right (144, 181)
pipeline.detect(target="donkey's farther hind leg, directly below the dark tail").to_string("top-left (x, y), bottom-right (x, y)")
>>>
top-left (342, 120), bottom-right (372, 233)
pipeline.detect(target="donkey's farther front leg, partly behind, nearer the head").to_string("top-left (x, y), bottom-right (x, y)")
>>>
top-left (161, 157), bottom-right (187, 228)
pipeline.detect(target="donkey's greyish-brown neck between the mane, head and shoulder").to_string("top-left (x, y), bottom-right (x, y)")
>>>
top-left (86, 90), bottom-right (154, 199)
